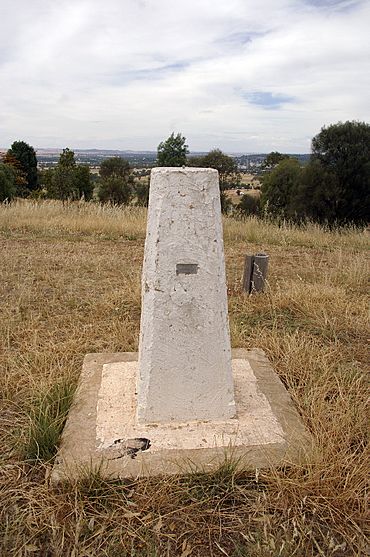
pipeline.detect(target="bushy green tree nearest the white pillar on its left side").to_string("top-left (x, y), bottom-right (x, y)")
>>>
top-left (98, 157), bottom-right (134, 205)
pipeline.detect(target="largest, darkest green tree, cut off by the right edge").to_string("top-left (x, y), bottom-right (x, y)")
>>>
top-left (308, 121), bottom-right (370, 223)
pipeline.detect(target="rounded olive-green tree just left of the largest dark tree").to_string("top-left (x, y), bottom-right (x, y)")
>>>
top-left (261, 159), bottom-right (302, 218)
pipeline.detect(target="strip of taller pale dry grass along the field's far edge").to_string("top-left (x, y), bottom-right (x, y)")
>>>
top-left (0, 200), bottom-right (369, 250)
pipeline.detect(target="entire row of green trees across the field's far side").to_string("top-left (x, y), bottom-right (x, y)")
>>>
top-left (0, 121), bottom-right (370, 224)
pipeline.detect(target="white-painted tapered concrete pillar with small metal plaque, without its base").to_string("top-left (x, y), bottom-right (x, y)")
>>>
top-left (137, 168), bottom-right (235, 423)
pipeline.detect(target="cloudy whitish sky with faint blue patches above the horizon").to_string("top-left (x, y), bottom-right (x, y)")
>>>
top-left (0, 0), bottom-right (370, 153)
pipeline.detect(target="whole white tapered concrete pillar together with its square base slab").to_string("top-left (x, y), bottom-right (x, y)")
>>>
top-left (52, 168), bottom-right (309, 483)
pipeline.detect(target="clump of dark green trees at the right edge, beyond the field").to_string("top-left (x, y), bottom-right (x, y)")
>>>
top-left (261, 122), bottom-right (370, 225)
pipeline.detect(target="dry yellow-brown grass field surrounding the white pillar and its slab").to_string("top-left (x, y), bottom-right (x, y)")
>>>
top-left (0, 201), bottom-right (369, 557)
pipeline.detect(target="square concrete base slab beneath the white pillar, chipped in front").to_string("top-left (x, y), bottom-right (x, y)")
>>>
top-left (51, 349), bottom-right (310, 483)
